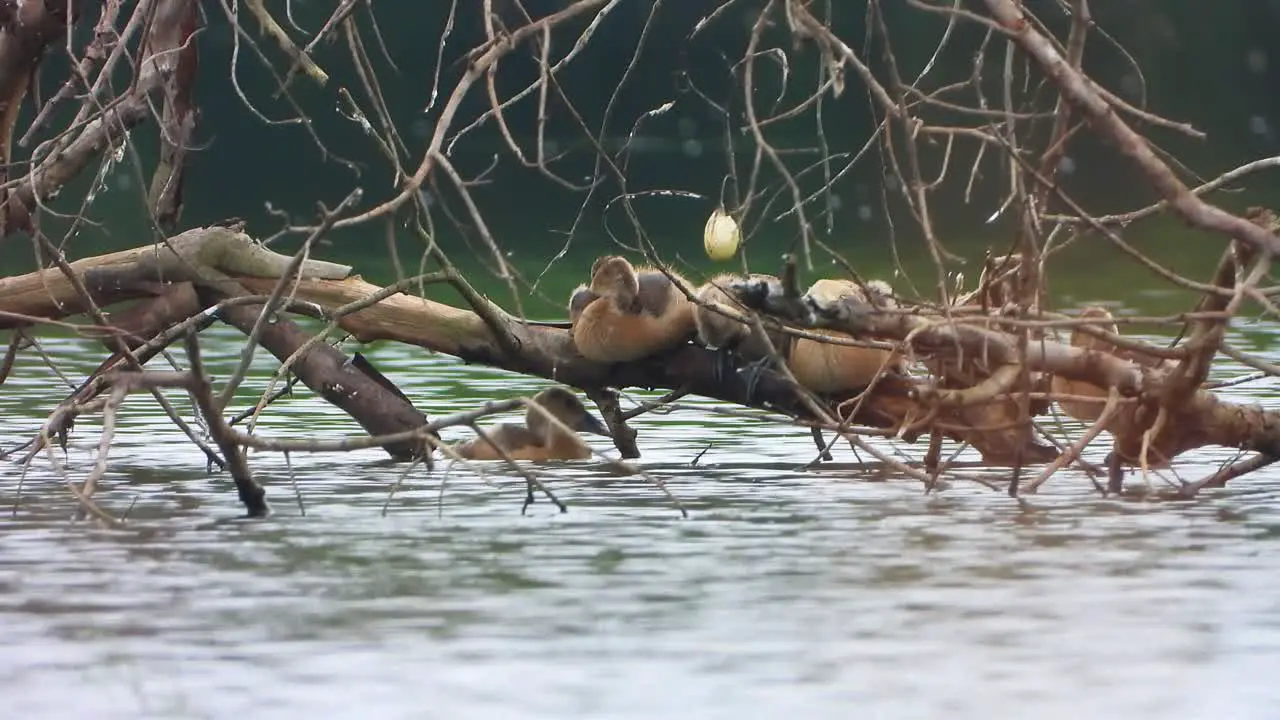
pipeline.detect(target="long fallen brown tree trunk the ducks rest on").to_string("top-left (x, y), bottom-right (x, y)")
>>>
top-left (0, 228), bottom-right (1280, 491)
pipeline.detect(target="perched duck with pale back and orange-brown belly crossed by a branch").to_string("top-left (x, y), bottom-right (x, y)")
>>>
top-left (787, 279), bottom-right (906, 395)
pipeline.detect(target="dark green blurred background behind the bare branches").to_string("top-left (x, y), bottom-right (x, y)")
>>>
top-left (0, 0), bottom-right (1280, 314)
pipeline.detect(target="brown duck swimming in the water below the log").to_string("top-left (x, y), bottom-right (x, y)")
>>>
top-left (454, 387), bottom-right (609, 460)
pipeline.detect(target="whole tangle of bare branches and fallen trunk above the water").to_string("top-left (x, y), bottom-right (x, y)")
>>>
top-left (0, 0), bottom-right (1280, 516)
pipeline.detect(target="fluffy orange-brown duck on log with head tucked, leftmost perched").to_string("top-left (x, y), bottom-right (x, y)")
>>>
top-left (568, 255), bottom-right (695, 363)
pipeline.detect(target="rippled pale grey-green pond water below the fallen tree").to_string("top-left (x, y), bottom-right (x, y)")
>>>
top-left (0, 299), bottom-right (1280, 720)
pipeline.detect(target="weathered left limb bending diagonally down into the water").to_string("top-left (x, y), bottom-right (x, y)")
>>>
top-left (0, 228), bottom-right (434, 468)
